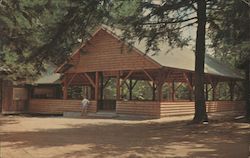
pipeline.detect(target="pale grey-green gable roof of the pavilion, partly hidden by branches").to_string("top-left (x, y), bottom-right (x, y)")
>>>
top-left (56, 25), bottom-right (243, 79)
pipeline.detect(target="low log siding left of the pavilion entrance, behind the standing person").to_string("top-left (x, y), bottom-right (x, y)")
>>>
top-left (29, 99), bottom-right (97, 114)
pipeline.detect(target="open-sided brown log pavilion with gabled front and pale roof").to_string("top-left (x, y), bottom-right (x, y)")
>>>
top-left (29, 26), bottom-right (244, 118)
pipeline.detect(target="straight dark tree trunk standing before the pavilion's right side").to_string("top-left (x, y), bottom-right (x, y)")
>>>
top-left (193, 0), bottom-right (207, 123)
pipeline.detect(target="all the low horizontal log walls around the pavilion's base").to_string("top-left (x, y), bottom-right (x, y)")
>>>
top-left (29, 99), bottom-right (244, 118)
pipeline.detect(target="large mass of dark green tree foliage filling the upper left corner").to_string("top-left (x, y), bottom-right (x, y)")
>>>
top-left (0, 0), bottom-right (112, 79)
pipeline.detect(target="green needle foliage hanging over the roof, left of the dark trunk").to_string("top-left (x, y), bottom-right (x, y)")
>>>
top-left (111, 0), bottom-right (196, 53)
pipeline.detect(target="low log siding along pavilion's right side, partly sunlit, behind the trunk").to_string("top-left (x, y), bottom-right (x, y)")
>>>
top-left (160, 101), bottom-right (245, 117)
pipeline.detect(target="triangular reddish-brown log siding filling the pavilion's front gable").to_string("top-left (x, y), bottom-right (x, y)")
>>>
top-left (66, 30), bottom-right (160, 73)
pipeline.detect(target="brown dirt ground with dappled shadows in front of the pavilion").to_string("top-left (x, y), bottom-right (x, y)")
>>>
top-left (0, 113), bottom-right (250, 158)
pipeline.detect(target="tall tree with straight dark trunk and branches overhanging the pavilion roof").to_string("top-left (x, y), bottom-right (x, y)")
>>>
top-left (111, 0), bottom-right (209, 123)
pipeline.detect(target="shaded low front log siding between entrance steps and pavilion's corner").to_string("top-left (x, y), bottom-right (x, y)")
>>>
top-left (116, 101), bottom-right (160, 118)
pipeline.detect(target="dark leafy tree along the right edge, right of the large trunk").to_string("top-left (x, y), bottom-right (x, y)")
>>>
top-left (209, 0), bottom-right (250, 120)
